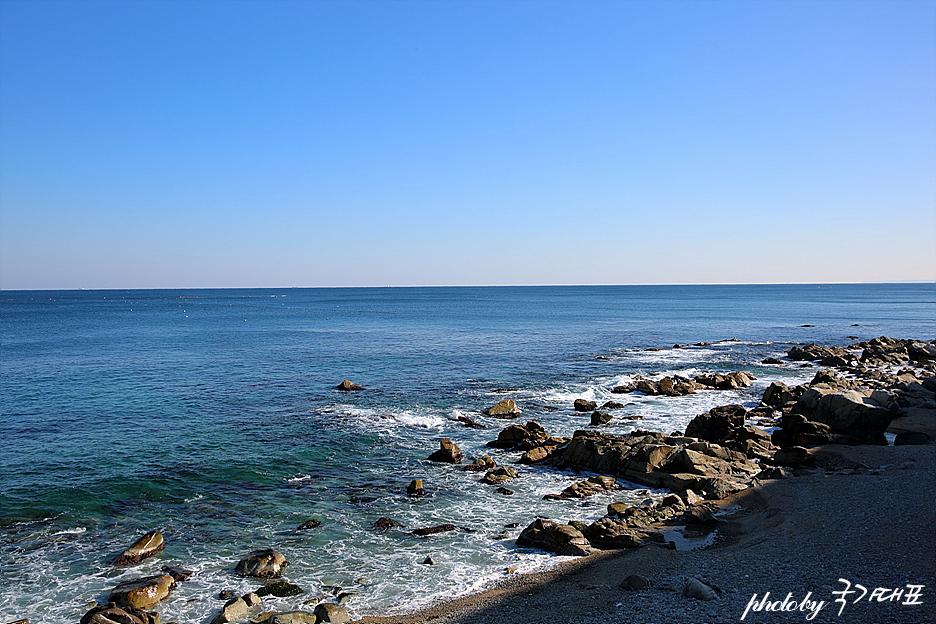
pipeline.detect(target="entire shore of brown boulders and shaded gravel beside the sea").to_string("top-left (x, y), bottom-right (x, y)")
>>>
top-left (60, 337), bottom-right (936, 624)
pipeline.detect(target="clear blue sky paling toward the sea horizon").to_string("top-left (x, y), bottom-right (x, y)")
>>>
top-left (0, 0), bottom-right (936, 289)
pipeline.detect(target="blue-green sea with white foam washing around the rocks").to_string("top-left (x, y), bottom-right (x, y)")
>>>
top-left (0, 283), bottom-right (936, 624)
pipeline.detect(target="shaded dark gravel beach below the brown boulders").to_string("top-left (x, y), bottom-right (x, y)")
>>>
top-left (356, 444), bottom-right (936, 624)
